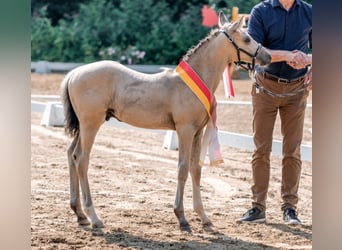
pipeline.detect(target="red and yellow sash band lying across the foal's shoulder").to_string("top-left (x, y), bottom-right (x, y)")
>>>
top-left (176, 60), bottom-right (211, 116)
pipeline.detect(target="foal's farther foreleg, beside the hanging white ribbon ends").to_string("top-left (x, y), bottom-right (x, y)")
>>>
top-left (190, 130), bottom-right (212, 225)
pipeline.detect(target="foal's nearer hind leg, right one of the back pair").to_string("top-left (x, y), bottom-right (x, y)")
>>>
top-left (76, 123), bottom-right (103, 228)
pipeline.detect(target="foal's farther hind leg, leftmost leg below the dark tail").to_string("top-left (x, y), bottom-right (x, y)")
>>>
top-left (67, 135), bottom-right (90, 225)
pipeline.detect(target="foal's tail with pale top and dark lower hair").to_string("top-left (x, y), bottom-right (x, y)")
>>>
top-left (61, 74), bottom-right (80, 137)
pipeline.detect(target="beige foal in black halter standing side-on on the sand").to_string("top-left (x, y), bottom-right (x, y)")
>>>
top-left (61, 12), bottom-right (271, 229)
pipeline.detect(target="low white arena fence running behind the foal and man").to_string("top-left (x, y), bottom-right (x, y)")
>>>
top-left (31, 95), bottom-right (312, 161)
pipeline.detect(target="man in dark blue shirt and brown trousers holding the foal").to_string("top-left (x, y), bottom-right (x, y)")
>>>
top-left (238, 0), bottom-right (312, 224)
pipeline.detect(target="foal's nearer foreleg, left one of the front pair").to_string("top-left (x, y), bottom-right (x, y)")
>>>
top-left (174, 131), bottom-right (193, 230)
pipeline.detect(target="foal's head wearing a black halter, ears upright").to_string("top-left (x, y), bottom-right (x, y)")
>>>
top-left (218, 12), bottom-right (271, 69)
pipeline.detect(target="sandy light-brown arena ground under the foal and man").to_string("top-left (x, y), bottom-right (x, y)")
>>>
top-left (31, 73), bottom-right (312, 250)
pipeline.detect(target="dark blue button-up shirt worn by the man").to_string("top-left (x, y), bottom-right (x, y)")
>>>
top-left (248, 0), bottom-right (312, 79)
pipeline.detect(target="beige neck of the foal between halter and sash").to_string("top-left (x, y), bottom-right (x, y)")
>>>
top-left (189, 37), bottom-right (231, 93)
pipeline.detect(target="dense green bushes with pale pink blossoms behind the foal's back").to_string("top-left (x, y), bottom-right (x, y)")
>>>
top-left (31, 0), bottom-right (209, 64)
